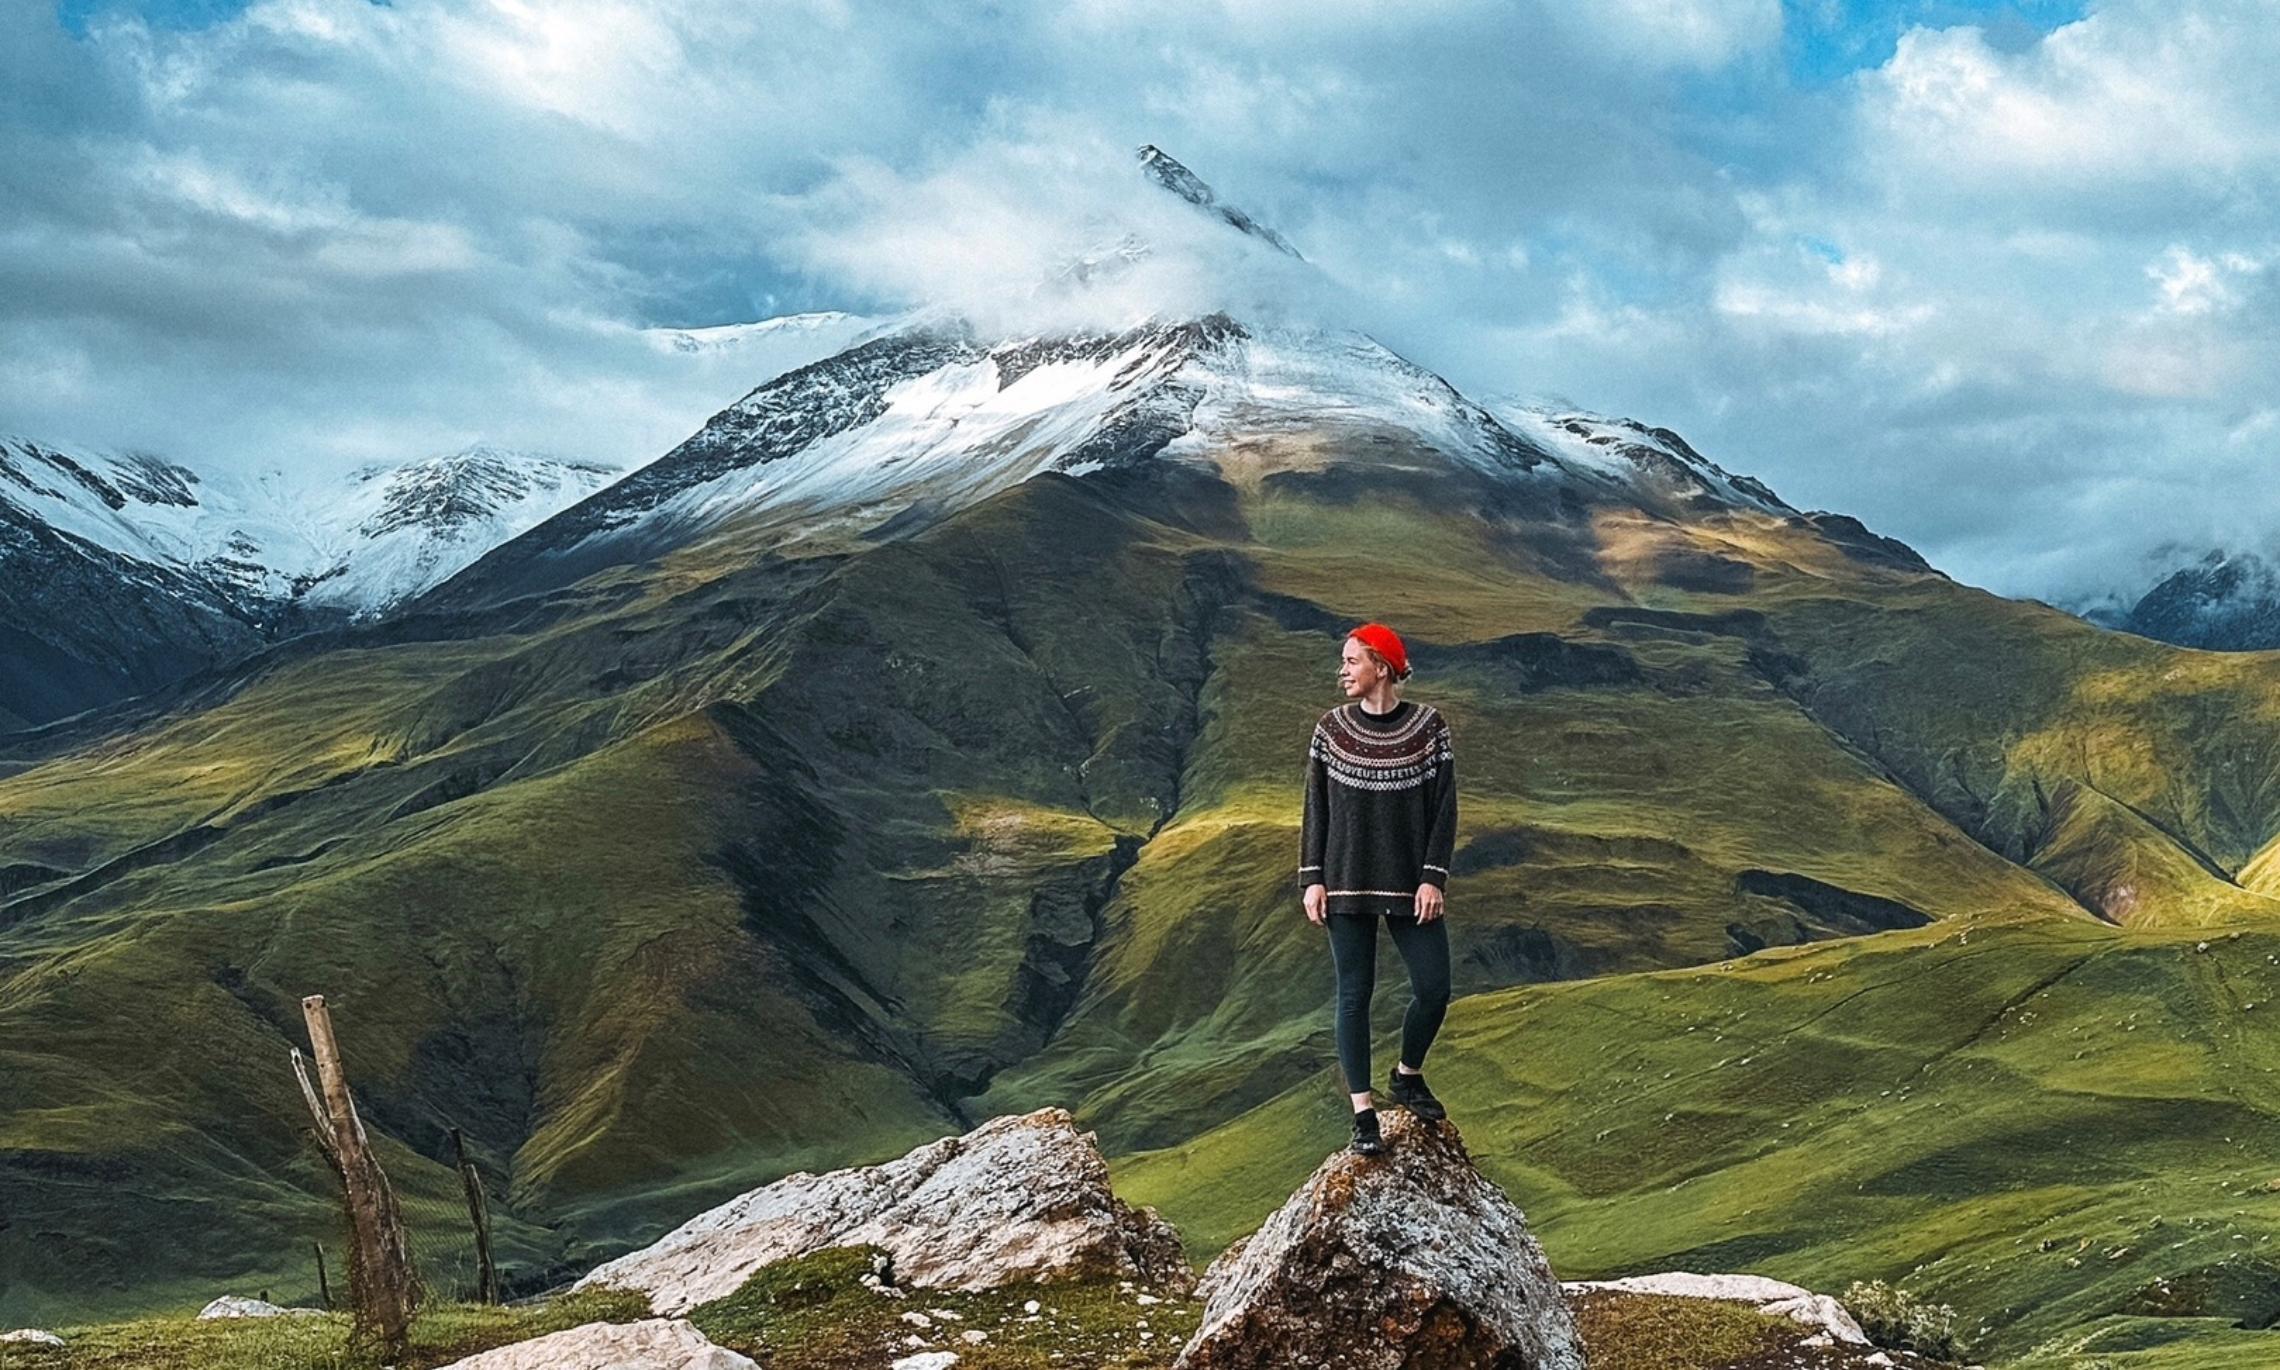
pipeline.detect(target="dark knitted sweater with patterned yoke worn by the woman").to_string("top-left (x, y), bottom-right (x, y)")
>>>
top-left (1297, 700), bottom-right (1457, 914)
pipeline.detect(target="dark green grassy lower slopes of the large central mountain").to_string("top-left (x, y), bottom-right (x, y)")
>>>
top-left (13, 431), bottom-right (2280, 1358)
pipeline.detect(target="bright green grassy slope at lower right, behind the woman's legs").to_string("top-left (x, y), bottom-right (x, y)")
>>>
top-left (1113, 916), bottom-right (2280, 1363)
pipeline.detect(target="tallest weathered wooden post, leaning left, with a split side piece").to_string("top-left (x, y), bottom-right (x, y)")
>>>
top-left (292, 994), bottom-right (420, 1356)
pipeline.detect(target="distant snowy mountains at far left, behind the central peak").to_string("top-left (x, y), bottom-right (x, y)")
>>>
top-left (0, 438), bottom-right (618, 727)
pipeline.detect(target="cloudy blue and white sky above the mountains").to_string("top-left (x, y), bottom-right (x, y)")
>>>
top-left (0, 0), bottom-right (2280, 600)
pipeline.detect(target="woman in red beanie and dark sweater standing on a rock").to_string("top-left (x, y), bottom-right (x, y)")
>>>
top-left (1297, 622), bottom-right (1457, 1156)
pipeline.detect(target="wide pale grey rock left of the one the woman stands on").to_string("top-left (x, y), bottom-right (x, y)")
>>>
top-left (572, 1108), bottom-right (1195, 1313)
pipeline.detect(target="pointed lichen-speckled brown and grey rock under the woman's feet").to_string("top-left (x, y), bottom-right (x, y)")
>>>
top-left (1176, 1112), bottom-right (1585, 1370)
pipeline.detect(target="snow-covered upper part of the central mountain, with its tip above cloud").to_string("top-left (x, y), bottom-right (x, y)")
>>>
top-left (435, 146), bottom-right (1922, 604)
